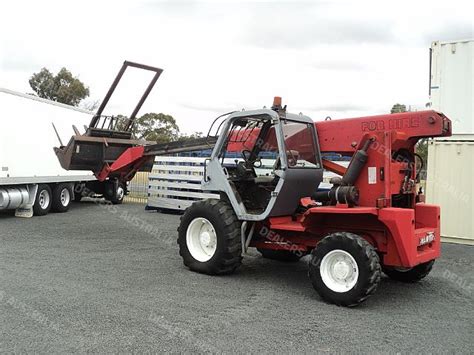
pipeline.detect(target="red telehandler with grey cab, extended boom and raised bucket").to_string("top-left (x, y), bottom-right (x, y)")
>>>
top-left (56, 62), bottom-right (451, 306)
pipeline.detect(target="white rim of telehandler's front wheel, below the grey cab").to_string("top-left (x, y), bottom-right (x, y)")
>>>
top-left (186, 217), bottom-right (217, 262)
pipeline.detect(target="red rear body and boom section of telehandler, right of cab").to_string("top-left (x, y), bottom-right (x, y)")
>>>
top-left (251, 111), bottom-right (451, 268)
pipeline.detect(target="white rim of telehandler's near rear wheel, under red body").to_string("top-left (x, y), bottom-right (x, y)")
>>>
top-left (319, 249), bottom-right (359, 293)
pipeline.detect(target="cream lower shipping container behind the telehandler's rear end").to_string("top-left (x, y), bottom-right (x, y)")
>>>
top-left (426, 134), bottom-right (474, 245)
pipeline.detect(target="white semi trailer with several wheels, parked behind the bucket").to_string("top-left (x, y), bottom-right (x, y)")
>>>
top-left (0, 88), bottom-right (123, 217)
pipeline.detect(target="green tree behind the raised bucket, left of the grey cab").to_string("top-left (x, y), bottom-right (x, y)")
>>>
top-left (133, 112), bottom-right (180, 143)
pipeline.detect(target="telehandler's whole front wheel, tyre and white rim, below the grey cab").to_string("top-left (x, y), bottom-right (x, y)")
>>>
top-left (178, 200), bottom-right (242, 275)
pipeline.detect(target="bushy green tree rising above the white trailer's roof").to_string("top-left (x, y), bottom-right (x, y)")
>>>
top-left (29, 68), bottom-right (89, 106)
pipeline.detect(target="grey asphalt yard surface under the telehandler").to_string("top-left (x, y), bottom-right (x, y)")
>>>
top-left (0, 202), bottom-right (474, 353)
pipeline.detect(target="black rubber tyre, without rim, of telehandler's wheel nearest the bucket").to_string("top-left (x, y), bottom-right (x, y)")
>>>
top-left (178, 200), bottom-right (242, 275)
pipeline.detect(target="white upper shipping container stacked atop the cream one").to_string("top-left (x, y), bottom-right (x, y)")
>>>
top-left (430, 39), bottom-right (474, 134)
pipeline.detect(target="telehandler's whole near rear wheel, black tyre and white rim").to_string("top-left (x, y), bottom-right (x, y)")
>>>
top-left (309, 232), bottom-right (381, 307)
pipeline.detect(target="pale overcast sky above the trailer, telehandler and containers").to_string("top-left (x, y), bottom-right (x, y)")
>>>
top-left (0, 0), bottom-right (474, 133)
